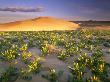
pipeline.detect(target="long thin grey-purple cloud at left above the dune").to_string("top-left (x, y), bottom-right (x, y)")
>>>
top-left (0, 7), bottom-right (44, 12)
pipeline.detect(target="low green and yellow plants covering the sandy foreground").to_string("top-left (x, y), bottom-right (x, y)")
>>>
top-left (0, 28), bottom-right (110, 82)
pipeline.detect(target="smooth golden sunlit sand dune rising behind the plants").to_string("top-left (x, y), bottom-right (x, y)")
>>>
top-left (0, 17), bottom-right (79, 31)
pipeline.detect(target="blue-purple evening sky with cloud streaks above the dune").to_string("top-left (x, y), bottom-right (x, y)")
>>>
top-left (0, 0), bottom-right (110, 23)
